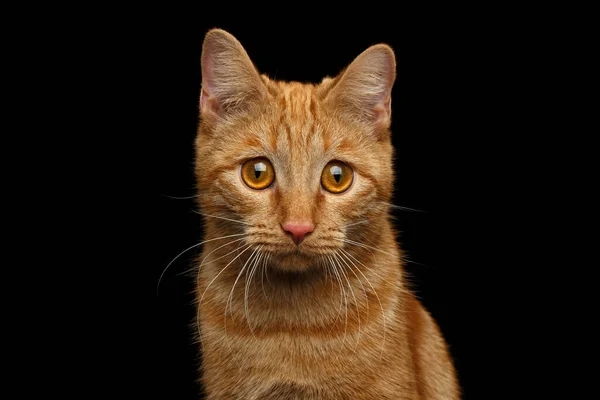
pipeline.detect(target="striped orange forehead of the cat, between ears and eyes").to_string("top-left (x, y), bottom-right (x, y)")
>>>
top-left (216, 81), bottom-right (373, 164)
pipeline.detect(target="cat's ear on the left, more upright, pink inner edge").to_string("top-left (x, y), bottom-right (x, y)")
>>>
top-left (200, 29), bottom-right (266, 116)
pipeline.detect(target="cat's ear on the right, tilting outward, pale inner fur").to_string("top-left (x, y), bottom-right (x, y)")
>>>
top-left (325, 44), bottom-right (396, 128)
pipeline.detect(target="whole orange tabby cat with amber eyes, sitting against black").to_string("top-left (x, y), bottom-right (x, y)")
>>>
top-left (195, 29), bottom-right (460, 400)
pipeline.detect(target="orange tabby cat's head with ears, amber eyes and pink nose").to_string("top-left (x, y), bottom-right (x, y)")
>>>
top-left (196, 29), bottom-right (396, 271)
